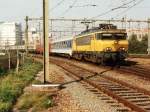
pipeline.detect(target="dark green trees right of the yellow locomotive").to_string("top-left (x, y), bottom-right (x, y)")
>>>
top-left (129, 34), bottom-right (148, 54)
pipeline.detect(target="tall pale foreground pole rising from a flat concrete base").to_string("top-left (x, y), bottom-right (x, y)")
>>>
top-left (43, 0), bottom-right (49, 83)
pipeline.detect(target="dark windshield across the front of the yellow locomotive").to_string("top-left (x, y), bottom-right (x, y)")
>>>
top-left (96, 33), bottom-right (127, 40)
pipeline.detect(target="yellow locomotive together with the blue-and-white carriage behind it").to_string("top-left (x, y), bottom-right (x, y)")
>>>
top-left (35, 24), bottom-right (128, 64)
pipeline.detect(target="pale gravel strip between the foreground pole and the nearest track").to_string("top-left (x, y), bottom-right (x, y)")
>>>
top-left (46, 64), bottom-right (131, 112)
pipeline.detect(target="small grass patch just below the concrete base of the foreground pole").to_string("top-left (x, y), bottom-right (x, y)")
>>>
top-left (17, 93), bottom-right (54, 112)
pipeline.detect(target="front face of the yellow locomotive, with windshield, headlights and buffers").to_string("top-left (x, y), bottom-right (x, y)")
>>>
top-left (95, 30), bottom-right (128, 62)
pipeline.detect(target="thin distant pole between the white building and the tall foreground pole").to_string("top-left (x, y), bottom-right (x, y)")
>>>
top-left (25, 16), bottom-right (29, 55)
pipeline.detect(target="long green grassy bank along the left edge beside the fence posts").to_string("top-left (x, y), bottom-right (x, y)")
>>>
top-left (0, 60), bottom-right (42, 112)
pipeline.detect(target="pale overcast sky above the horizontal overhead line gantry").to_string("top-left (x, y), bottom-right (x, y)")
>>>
top-left (0, 0), bottom-right (150, 22)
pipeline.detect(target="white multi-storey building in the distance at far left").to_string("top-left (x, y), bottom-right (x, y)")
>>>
top-left (0, 22), bottom-right (22, 46)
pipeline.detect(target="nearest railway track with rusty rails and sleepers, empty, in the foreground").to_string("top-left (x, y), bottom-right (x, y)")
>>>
top-left (32, 54), bottom-right (150, 112)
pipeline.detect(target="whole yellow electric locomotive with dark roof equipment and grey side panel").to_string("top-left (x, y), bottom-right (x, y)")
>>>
top-left (73, 24), bottom-right (128, 63)
